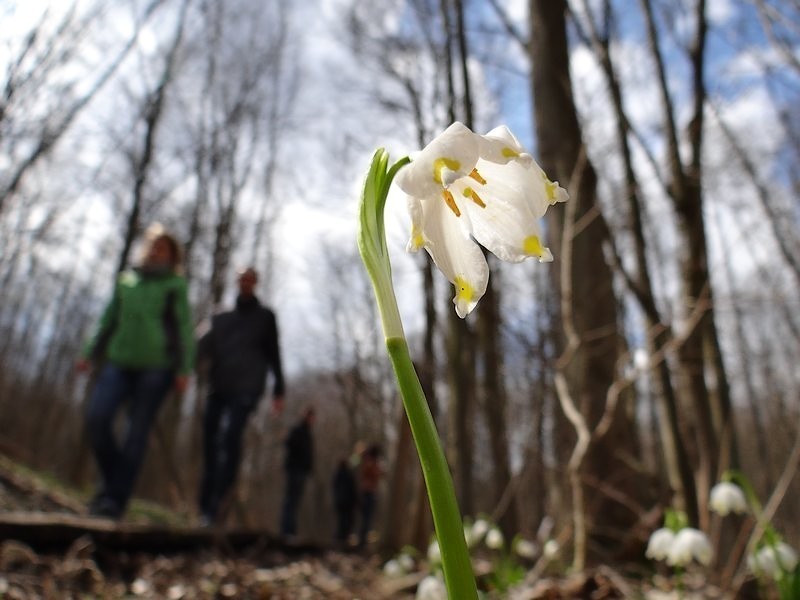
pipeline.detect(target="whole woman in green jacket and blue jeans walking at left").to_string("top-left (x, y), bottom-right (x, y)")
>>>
top-left (78, 226), bottom-right (194, 518)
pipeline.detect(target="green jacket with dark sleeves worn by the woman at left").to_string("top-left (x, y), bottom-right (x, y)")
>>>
top-left (83, 271), bottom-right (195, 375)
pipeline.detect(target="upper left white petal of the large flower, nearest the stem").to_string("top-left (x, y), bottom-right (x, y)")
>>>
top-left (395, 122), bottom-right (480, 199)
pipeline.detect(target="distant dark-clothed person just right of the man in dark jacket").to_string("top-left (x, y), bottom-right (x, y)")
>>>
top-left (281, 408), bottom-right (314, 536)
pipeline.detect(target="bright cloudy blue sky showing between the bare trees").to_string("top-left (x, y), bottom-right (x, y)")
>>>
top-left (0, 0), bottom-right (796, 384)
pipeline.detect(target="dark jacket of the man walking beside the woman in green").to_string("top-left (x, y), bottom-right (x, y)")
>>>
top-left (198, 296), bottom-right (284, 396)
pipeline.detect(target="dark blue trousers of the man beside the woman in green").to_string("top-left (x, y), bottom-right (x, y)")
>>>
top-left (199, 393), bottom-right (259, 522)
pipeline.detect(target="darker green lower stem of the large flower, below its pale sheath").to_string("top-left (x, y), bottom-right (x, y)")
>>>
top-left (386, 337), bottom-right (478, 600)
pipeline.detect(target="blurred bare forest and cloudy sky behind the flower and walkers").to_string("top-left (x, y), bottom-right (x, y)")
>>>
top-left (0, 0), bottom-right (800, 580)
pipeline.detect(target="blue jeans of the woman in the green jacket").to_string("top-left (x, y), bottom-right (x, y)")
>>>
top-left (86, 364), bottom-right (175, 516)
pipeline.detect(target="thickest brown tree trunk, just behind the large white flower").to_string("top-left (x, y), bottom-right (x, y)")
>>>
top-left (529, 0), bottom-right (644, 550)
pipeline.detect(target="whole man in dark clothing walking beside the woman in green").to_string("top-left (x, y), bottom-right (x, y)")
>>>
top-left (198, 268), bottom-right (284, 525)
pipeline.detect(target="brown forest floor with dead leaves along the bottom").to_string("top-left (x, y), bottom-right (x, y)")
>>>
top-left (0, 454), bottom-right (726, 600)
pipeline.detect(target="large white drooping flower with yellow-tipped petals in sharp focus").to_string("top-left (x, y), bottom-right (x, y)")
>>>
top-left (395, 122), bottom-right (568, 318)
